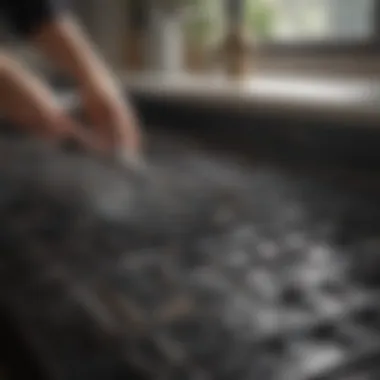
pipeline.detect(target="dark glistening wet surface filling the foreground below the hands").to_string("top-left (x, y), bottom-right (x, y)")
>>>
top-left (0, 134), bottom-right (380, 380)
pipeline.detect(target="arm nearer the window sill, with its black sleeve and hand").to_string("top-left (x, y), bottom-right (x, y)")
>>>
top-left (0, 0), bottom-right (140, 152)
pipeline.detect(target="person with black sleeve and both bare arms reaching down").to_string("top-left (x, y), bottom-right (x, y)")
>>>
top-left (0, 0), bottom-right (141, 153)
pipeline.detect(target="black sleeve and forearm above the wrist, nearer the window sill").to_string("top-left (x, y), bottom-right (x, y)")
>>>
top-left (0, 0), bottom-right (102, 84)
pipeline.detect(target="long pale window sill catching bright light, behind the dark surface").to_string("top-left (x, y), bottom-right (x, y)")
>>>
top-left (122, 73), bottom-right (380, 127)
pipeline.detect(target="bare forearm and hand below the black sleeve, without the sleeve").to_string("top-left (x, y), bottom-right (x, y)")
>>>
top-left (33, 13), bottom-right (141, 152)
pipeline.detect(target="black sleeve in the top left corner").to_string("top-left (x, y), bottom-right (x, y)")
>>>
top-left (0, 0), bottom-right (69, 37)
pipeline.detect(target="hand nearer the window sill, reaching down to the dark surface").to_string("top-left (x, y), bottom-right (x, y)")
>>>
top-left (81, 77), bottom-right (141, 154)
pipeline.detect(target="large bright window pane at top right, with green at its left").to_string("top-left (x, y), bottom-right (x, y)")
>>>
top-left (245, 0), bottom-right (376, 43)
